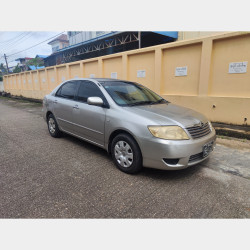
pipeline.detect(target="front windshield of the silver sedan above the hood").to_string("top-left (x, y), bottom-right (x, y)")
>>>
top-left (100, 81), bottom-right (168, 106)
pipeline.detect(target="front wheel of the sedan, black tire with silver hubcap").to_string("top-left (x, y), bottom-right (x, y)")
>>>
top-left (111, 133), bottom-right (142, 174)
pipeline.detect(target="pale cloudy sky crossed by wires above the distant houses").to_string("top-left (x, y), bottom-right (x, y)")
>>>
top-left (0, 31), bottom-right (66, 67)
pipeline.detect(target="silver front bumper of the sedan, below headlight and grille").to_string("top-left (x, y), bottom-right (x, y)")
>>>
top-left (139, 129), bottom-right (216, 170)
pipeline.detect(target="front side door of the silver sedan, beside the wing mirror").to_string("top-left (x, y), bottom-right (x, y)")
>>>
top-left (73, 80), bottom-right (108, 146)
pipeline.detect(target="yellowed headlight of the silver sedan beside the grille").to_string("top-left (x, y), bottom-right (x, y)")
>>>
top-left (148, 126), bottom-right (189, 140)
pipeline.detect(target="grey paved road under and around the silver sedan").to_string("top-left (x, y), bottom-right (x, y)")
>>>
top-left (0, 98), bottom-right (250, 218)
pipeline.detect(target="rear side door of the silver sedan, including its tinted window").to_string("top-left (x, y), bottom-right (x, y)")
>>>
top-left (53, 81), bottom-right (78, 133)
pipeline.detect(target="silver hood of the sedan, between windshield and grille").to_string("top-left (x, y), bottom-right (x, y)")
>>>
top-left (123, 103), bottom-right (207, 127)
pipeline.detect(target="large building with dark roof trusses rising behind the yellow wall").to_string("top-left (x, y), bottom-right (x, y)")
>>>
top-left (45, 31), bottom-right (178, 66)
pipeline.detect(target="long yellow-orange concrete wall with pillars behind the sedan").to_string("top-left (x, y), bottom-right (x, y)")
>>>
top-left (4, 32), bottom-right (250, 124)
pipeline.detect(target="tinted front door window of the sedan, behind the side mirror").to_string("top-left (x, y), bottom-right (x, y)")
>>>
top-left (77, 81), bottom-right (106, 102)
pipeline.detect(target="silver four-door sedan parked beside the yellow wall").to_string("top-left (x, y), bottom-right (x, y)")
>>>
top-left (43, 78), bottom-right (216, 173)
